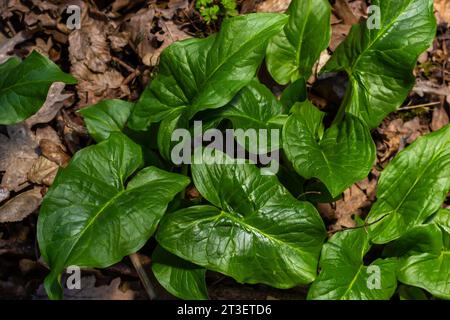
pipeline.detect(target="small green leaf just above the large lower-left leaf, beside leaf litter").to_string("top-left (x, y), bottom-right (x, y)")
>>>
top-left (78, 99), bottom-right (133, 142)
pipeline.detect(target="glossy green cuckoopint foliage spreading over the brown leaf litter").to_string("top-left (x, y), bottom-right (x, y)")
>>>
top-left (0, 0), bottom-right (450, 299)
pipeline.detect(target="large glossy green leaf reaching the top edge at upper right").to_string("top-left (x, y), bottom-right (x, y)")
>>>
top-left (322, 0), bottom-right (436, 128)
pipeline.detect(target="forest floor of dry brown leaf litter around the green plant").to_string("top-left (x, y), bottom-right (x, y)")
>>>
top-left (0, 0), bottom-right (450, 299)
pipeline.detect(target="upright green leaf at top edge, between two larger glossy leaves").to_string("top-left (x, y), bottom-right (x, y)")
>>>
top-left (266, 0), bottom-right (331, 84)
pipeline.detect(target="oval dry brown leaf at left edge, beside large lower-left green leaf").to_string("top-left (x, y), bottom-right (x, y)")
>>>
top-left (0, 187), bottom-right (42, 222)
